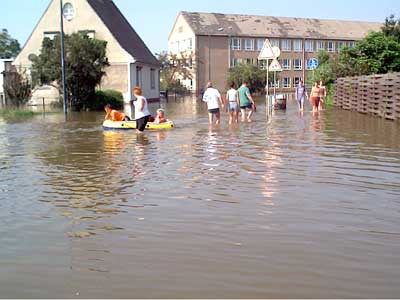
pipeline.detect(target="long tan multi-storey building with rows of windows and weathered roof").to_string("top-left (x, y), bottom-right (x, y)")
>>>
top-left (168, 12), bottom-right (382, 93)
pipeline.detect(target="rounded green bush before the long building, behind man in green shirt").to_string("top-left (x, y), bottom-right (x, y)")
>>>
top-left (227, 64), bottom-right (266, 91)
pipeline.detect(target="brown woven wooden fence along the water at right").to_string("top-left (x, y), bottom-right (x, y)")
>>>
top-left (334, 73), bottom-right (400, 120)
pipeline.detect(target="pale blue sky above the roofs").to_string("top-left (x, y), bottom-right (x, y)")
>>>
top-left (0, 0), bottom-right (400, 52)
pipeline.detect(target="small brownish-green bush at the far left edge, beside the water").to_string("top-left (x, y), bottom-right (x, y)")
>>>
top-left (4, 69), bottom-right (31, 107)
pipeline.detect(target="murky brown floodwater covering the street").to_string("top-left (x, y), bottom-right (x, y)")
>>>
top-left (0, 99), bottom-right (400, 298)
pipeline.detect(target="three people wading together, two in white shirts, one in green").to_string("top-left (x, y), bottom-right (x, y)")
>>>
top-left (203, 81), bottom-right (257, 124)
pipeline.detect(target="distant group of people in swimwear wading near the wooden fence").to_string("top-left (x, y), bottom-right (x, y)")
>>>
top-left (295, 80), bottom-right (326, 112)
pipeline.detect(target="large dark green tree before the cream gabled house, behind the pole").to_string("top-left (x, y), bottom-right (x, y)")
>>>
top-left (30, 33), bottom-right (109, 110)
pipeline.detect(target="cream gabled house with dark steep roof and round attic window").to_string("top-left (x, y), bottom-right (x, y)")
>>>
top-left (14, 0), bottom-right (160, 101)
